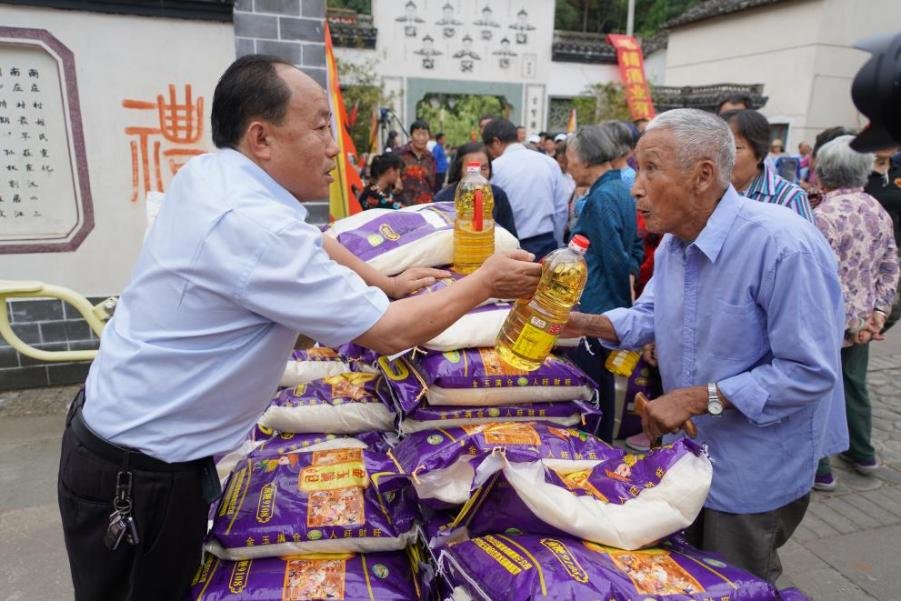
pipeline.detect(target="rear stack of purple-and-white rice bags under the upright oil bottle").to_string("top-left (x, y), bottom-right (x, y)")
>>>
top-left (325, 203), bottom-right (595, 434)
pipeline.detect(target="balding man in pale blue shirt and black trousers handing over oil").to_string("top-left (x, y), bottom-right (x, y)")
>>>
top-left (58, 55), bottom-right (540, 601)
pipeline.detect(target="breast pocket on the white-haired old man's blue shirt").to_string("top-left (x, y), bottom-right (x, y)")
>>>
top-left (707, 298), bottom-right (766, 365)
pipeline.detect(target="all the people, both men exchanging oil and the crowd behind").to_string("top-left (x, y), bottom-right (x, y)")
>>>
top-left (58, 55), bottom-right (901, 600)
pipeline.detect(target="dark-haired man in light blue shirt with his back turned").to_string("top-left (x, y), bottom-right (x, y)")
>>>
top-left (482, 119), bottom-right (571, 258)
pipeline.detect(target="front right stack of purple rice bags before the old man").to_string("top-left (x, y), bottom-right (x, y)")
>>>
top-left (395, 422), bottom-right (816, 601)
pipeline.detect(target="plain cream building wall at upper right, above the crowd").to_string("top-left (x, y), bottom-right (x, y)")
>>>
top-left (665, 0), bottom-right (901, 151)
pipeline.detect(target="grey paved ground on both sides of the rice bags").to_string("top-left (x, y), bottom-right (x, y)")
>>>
top-left (0, 327), bottom-right (901, 601)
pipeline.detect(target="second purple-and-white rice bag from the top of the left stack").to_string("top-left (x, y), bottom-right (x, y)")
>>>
top-left (259, 372), bottom-right (394, 434)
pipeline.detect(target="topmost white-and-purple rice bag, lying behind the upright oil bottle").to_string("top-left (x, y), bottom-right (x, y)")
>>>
top-left (325, 202), bottom-right (519, 275)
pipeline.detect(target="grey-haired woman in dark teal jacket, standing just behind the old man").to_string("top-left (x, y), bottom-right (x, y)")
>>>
top-left (566, 125), bottom-right (644, 441)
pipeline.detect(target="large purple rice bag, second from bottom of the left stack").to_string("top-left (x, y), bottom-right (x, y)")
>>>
top-left (207, 446), bottom-right (416, 560)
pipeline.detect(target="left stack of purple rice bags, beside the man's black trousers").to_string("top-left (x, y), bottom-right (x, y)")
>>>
top-left (196, 345), bottom-right (421, 601)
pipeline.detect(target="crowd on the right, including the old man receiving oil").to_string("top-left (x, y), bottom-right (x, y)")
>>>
top-left (354, 94), bottom-right (901, 579)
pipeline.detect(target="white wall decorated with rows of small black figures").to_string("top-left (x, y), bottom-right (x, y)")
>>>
top-left (335, 0), bottom-right (556, 132)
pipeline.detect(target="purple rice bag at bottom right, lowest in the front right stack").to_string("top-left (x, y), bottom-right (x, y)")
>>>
top-left (440, 534), bottom-right (779, 601)
